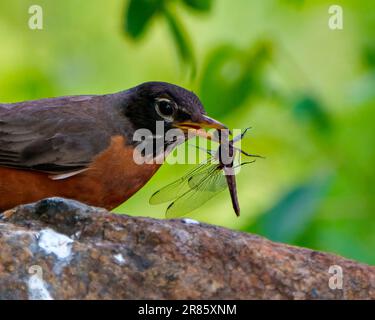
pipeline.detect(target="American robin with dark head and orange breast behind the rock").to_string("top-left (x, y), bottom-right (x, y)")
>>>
top-left (0, 82), bottom-right (225, 212)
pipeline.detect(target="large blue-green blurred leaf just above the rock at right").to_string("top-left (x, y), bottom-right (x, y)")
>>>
top-left (245, 177), bottom-right (332, 243)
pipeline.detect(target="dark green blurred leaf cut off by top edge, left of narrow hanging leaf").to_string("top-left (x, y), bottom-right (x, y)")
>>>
top-left (125, 0), bottom-right (164, 39)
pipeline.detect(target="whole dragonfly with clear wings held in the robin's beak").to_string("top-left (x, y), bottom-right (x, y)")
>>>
top-left (149, 128), bottom-right (262, 218)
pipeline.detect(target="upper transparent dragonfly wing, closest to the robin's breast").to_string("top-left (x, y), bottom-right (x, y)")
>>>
top-left (149, 158), bottom-right (216, 205)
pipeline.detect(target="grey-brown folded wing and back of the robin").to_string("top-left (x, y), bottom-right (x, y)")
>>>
top-left (0, 96), bottom-right (124, 174)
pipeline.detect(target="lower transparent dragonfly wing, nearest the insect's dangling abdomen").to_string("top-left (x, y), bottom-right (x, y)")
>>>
top-left (166, 166), bottom-right (227, 218)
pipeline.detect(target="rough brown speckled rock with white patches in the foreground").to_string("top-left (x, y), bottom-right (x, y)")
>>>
top-left (0, 198), bottom-right (375, 299)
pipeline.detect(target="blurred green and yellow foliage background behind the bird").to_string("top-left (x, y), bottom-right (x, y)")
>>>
top-left (0, 0), bottom-right (375, 264)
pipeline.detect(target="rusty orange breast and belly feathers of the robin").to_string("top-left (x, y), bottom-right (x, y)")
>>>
top-left (0, 136), bottom-right (160, 211)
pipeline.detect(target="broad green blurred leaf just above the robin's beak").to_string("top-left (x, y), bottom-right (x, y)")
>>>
top-left (199, 42), bottom-right (270, 116)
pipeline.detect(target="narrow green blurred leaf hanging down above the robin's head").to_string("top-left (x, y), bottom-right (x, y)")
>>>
top-left (163, 7), bottom-right (195, 69)
